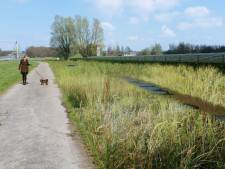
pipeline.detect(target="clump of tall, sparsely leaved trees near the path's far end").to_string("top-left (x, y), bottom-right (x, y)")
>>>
top-left (50, 16), bottom-right (104, 59)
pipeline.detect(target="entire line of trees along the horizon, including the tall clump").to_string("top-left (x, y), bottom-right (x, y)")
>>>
top-left (24, 13), bottom-right (225, 59)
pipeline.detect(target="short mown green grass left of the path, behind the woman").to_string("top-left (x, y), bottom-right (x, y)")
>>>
top-left (0, 61), bottom-right (37, 94)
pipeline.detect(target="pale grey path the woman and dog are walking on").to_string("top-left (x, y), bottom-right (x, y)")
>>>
top-left (0, 63), bottom-right (93, 169)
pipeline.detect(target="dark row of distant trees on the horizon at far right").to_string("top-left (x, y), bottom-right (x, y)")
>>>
top-left (164, 42), bottom-right (225, 54)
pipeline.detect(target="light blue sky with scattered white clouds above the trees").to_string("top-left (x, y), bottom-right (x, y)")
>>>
top-left (0, 0), bottom-right (225, 50)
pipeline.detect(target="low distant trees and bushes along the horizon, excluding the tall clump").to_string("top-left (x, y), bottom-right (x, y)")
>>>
top-left (25, 42), bottom-right (225, 58)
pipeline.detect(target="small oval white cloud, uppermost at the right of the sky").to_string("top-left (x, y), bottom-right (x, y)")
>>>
top-left (184, 6), bottom-right (210, 17)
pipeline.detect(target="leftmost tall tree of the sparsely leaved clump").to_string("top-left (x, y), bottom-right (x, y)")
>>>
top-left (50, 16), bottom-right (76, 60)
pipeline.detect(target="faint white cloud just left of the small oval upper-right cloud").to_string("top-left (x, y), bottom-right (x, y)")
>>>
top-left (154, 11), bottom-right (180, 23)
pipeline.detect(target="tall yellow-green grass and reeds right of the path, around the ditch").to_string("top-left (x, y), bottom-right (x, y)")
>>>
top-left (50, 62), bottom-right (225, 169)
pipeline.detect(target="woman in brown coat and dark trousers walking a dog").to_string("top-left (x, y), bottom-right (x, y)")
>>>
top-left (19, 55), bottom-right (30, 85)
